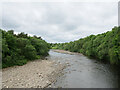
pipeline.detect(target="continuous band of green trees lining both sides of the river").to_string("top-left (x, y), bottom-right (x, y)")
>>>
top-left (0, 27), bottom-right (120, 68)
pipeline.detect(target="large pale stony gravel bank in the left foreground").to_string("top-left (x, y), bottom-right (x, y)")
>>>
top-left (2, 60), bottom-right (66, 88)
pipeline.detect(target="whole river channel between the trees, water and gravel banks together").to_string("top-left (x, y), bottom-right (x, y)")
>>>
top-left (2, 50), bottom-right (119, 88)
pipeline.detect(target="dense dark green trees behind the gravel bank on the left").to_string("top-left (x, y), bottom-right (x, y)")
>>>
top-left (0, 29), bottom-right (50, 68)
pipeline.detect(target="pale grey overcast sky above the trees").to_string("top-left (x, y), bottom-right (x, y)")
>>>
top-left (2, 2), bottom-right (118, 43)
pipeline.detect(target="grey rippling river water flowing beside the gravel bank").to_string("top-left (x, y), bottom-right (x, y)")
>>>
top-left (48, 50), bottom-right (119, 88)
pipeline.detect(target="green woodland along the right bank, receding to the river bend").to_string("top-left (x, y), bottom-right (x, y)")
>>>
top-left (51, 27), bottom-right (120, 65)
